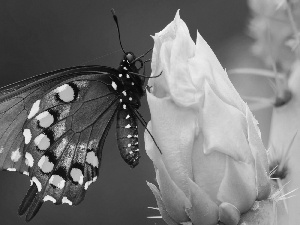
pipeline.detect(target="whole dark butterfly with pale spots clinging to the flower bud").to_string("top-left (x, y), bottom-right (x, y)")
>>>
top-left (0, 9), bottom-right (159, 221)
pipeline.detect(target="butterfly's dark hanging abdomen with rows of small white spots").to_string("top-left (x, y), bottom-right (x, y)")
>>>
top-left (117, 104), bottom-right (140, 168)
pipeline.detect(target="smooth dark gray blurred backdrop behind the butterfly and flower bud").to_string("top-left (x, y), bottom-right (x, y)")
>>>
top-left (0, 0), bottom-right (269, 225)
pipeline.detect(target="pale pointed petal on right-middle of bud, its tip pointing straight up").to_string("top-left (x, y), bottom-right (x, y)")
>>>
top-left (203, 82), bottom-right (254, 162)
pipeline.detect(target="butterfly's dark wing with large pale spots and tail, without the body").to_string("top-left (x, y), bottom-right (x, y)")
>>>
top-left (0, 67), bottom-right (129, 220)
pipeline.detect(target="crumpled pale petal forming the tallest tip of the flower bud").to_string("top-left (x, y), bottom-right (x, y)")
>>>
top-left (149, 11), bottom-right (200, 106)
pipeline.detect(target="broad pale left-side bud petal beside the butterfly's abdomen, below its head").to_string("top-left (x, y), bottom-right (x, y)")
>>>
top-left (145, 93), bottom-right (198, 195)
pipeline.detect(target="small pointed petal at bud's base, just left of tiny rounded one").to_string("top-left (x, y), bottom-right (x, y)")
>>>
top-left (186, 178), bottom-right (218, 225)
